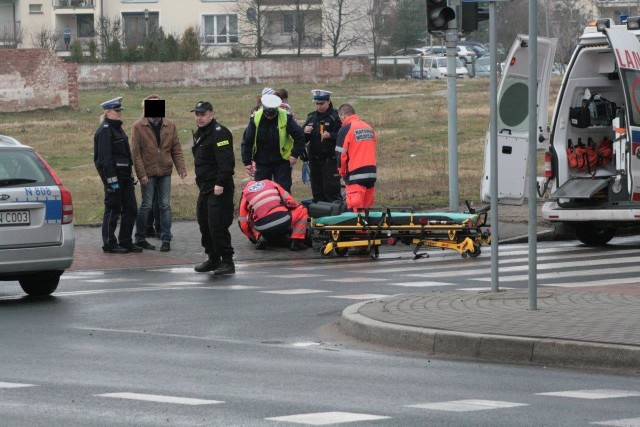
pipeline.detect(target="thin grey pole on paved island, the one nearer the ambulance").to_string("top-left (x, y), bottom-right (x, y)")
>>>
top-left (528, 0), bottom-right (538, 310)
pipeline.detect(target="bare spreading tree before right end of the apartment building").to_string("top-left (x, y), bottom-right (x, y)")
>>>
top-left (322, 0), bottom-right (367, 56)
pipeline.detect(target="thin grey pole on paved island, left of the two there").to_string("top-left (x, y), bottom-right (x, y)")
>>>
top-left (489, 2), bottom-right (500, 292)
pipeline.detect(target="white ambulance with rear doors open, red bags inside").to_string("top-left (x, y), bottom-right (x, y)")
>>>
top-left (481, 17), bottom-right (640, 246)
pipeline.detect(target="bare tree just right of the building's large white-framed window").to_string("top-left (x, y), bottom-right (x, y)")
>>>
top-left (238, 0), bottom-right (271, 58)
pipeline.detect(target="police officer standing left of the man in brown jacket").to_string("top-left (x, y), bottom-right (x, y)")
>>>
top-left (93, 97), bottom-right (142, 254)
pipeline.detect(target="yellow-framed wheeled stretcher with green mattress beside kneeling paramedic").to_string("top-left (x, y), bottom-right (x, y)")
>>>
top-left (310, 206), bottom-right (491, 259)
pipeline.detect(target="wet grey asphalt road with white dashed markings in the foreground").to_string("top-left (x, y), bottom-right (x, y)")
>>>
top-left (0, 241), bottom-right (640, 426)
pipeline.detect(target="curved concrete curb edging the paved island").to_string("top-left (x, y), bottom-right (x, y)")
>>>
top-left (340, 301), bottom-right (640, 372)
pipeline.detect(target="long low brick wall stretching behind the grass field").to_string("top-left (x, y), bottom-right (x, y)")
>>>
top-left (78, 57), bottom-right (371, 90)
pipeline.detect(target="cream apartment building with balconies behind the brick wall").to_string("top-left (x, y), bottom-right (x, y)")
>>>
top-left (0, 0), bottom-right (376, 56)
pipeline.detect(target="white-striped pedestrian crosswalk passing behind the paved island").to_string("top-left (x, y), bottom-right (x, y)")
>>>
top-left (45, 240), bottom-right (640, 299)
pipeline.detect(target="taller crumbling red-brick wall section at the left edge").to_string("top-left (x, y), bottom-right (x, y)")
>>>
top-left (0, 49), bottom-right (78, 112)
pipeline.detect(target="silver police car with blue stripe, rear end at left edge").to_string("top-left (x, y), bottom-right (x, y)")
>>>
top-left (0, 135), bottom-right (75, 296)
